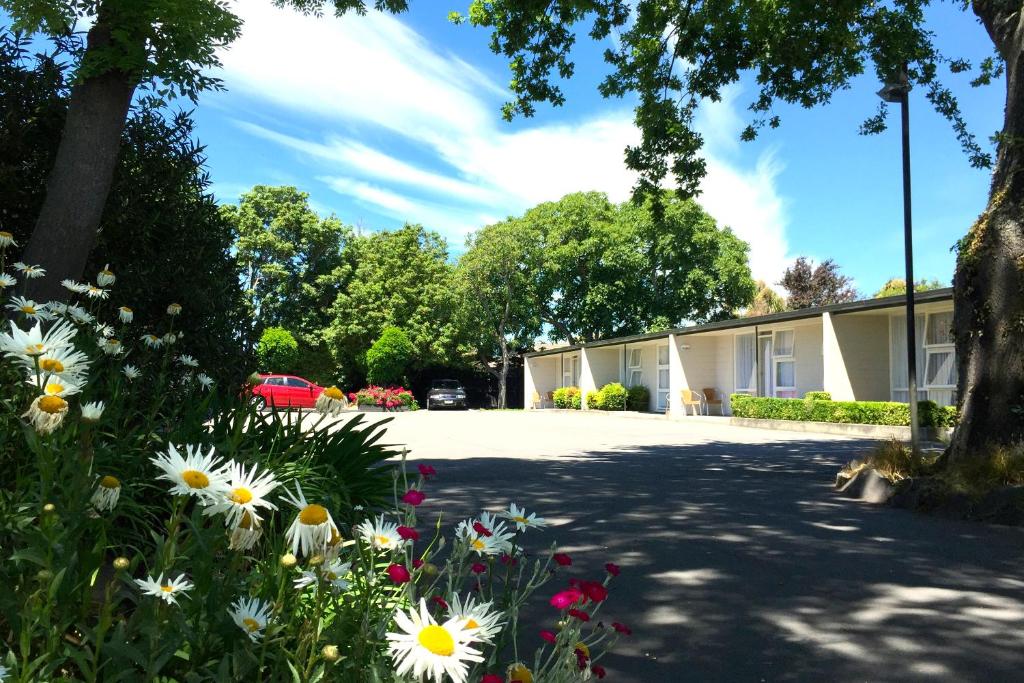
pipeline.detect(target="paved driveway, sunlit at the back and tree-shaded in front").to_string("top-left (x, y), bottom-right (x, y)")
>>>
top-left (350, 412), bottom-right (1024, 682)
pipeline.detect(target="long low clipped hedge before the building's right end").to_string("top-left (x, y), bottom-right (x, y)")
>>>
top-left (729, 393), bottom-right (955, 427)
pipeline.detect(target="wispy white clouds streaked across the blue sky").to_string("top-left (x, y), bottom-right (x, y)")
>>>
top-left (214, 2), bottom-right (787, 283)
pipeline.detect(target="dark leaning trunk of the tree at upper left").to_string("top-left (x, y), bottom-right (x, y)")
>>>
top-left (23, 23), bottom-right (136, 300)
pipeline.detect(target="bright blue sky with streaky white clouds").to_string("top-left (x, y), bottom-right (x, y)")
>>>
top-left (188, 0), bottom-right (1002, 294)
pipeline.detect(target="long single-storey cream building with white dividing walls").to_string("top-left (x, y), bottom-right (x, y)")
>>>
top-left (523, 288), bottom-right (956, 416)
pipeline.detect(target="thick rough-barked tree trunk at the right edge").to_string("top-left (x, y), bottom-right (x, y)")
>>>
top-left (948, 0), bottom-right (1024, 462)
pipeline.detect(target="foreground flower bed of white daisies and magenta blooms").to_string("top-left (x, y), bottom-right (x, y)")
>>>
top-left (0, 252), bottom-right (629, 683)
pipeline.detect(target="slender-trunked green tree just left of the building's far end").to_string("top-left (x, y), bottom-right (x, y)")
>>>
top-left (457, 219), bottom-right (541, 408)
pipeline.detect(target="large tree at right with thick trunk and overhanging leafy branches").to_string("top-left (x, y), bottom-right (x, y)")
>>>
top-left (464, 0), bottom-right (1024, 461)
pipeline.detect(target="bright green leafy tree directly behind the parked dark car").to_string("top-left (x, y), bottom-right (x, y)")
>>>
top-left (324, 224), bottom-right (460, 381)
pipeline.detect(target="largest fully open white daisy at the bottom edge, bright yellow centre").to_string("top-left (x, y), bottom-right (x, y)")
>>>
top-left (387, 598), bottom-right (483, 683)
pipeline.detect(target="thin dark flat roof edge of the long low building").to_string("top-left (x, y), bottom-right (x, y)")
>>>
top-left (524, 287), bottom-right (953, 358)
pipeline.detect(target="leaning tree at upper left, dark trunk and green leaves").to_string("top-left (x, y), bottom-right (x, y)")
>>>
top-left (6, 0), bottom-right (408, 299)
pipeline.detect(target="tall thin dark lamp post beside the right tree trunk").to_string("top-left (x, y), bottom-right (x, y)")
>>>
top-left (879, 67), bottom-right (921, 453)
